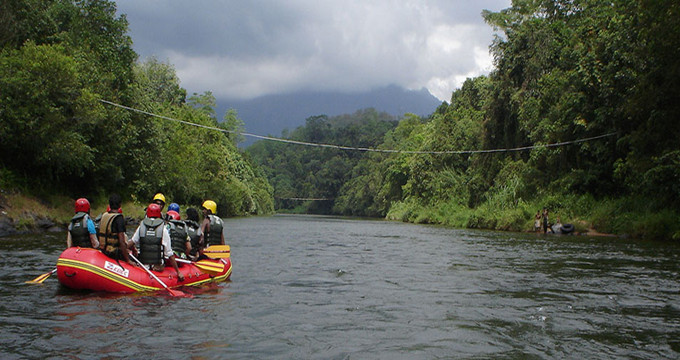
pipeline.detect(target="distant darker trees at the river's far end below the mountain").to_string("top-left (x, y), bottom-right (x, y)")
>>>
top-left (248, 109), bottom-right (397, 215)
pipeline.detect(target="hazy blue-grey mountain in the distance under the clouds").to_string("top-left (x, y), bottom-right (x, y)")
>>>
top-left (216, 85), bottom-right (441, 146)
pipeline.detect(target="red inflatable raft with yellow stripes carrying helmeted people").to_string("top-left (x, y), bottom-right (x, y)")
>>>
top-left (57, 247), bottom-right (231, 293)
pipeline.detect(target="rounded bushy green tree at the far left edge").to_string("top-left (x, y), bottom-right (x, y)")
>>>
top-left (0, 41), bottom-right (96, 190)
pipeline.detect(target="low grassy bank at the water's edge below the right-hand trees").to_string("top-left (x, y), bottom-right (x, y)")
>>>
top-left (387, 195), bottom-right (680, 241)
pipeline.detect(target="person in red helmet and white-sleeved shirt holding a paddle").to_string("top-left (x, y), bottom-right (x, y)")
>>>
top-left (130, 203), bottom-right (184, 281)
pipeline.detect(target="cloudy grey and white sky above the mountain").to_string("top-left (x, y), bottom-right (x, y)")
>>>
top-left (116, 0), bottom-right (511, 101)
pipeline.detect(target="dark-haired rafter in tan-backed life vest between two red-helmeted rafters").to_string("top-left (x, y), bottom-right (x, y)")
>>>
top-left (97, 194), bottom-right (134, 265)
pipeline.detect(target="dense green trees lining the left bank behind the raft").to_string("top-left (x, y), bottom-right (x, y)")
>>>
top-left (0, 0), bottom-right (273, 215)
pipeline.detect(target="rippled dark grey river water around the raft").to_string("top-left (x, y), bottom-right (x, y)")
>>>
top-left (0, 215), bottom-right (680, 359)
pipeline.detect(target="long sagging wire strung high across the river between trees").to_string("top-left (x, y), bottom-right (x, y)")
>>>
top-left (99, 99), bottom-right (616, 155)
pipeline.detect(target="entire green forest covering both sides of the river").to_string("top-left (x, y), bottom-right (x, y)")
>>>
top-left (0, 0), bottom-right (680, 240)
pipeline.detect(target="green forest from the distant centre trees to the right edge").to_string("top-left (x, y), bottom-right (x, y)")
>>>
top-left (248, 0), bottom-right (680, 240)
